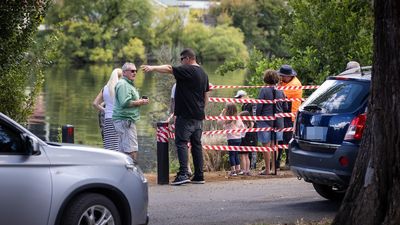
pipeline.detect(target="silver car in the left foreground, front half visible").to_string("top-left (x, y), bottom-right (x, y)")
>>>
top-left (0, 113), bottom-right (148, 225)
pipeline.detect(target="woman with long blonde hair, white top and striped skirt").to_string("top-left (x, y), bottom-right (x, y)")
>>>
top-left (93, 68), bottom-right (122, 151)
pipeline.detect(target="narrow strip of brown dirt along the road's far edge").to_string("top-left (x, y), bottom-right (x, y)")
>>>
top-left (145, 170), bottom-right (294, 185)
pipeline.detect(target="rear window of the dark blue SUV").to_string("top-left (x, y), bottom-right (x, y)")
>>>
top-left (302, 80), bottom-right (369, 113)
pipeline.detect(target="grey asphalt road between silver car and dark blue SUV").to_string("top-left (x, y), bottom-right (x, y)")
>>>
top-left (149, 177), bottom-right (340, 225)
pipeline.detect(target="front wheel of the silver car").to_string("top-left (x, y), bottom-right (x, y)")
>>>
top-left (61, 193), bottom-right (121, 225)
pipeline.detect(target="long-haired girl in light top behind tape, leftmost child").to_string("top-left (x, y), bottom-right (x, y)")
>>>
top-left (219, 102), bottom-right (245, 176)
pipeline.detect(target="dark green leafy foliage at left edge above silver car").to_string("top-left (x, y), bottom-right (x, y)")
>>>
top-left (0, 1), bottom-right (51, 122)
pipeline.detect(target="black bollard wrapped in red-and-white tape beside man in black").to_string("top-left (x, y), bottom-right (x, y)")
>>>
top-left (157, 122), bottom-right (169, 184)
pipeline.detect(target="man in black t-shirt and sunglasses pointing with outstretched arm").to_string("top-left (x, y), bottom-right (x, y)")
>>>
top-left (141, 49), bottom-right (209, 185)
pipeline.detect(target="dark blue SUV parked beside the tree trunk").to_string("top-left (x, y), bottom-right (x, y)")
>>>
top-left (289, 67), bottom-right (371, 200)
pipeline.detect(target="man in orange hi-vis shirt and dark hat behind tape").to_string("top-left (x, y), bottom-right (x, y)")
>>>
top-left (276, 65), bottom-right (303, 168)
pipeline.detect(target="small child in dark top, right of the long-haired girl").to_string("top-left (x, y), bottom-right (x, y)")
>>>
top-left (239, 111), bottom-right (257, 176)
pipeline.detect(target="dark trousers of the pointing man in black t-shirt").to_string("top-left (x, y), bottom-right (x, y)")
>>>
top-left (175, 117), bottom-right (203, 177)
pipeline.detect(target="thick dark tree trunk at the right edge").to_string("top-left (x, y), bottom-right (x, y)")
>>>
top-left (333, 0), bottom-right (400, 225)
